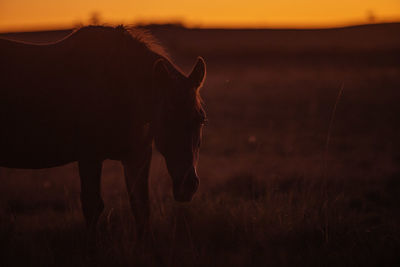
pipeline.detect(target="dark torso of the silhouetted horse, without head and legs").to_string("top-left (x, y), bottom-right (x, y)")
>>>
top-left (0, 27), bottom-right (156, 168)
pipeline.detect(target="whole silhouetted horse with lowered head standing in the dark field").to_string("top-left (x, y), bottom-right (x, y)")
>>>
top-left (0, 26), bottom-right (206, 238)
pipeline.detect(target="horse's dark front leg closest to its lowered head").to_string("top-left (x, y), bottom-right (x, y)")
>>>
top-left (122, 146), bottom-right (152, 242)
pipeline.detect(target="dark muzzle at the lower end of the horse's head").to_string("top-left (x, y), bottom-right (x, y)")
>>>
top-left (173, 167), bottom-right (199, 202)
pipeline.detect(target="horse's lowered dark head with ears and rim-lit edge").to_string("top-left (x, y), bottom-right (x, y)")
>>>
top-left (152, 57), bottom-right (206, 202)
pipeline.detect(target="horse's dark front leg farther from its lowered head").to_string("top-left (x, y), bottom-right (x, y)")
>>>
top-left (78, 161), bottom-right (104, 230)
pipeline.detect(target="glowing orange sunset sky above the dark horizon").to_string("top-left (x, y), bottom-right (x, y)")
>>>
top-left (0, 0), bottom-right (400, 31)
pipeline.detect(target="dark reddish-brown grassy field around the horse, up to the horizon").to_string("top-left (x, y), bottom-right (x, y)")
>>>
top-left (0, 24), bottom-right (400, 266)
